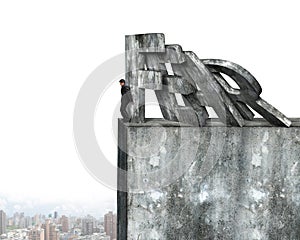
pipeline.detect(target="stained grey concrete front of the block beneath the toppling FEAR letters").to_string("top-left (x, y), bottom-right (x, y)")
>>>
top-left (118, 119), bottom-right (300, 240)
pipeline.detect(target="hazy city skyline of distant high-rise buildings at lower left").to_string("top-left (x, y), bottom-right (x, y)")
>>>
top-left (0, 209), bottom-right (117, 240)
